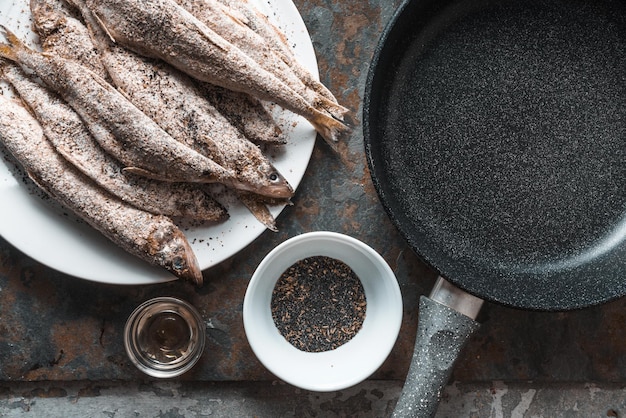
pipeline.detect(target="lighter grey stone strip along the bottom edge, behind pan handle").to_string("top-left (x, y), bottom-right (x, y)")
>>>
top-left (0, 380), bottom-right (626, 418)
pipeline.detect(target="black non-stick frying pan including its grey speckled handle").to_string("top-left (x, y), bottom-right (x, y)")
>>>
top-left (363, 0), bottom-right (626, 416)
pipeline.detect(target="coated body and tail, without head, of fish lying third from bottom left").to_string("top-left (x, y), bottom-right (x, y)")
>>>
top-left (0, 27), bottom-right (237, 187)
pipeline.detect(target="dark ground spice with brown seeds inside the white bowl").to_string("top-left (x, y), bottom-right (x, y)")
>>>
top-left (271, 256), bottom-right (366, 352)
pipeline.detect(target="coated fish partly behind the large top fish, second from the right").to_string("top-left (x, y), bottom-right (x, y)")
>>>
top-left (175, 0), bottom-right (348, 119)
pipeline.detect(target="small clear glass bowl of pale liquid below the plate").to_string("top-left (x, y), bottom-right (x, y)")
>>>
top-left (124, 297), bottom-right (206, 378)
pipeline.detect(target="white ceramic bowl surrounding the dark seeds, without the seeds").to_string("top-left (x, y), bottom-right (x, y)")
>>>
top-left (243, 232), bottom-right (402, 392)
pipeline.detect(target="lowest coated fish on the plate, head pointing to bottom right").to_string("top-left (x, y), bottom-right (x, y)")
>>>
top-left (0, 96), bottom-right (202, 285)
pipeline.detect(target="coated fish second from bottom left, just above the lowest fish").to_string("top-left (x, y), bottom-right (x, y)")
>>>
top-left (0, 65), bottom-right (228, 221)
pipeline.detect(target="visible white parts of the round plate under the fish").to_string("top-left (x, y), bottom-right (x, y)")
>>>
top-left (0, 0), bottom-right (318, 284)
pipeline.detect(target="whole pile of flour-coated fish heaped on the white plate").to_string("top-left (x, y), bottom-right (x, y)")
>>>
top-left (0, 0), bottom-right (348, 284)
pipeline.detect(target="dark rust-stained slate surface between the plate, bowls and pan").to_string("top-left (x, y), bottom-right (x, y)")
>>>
top-left (0, 0), bottom-right (626, 382)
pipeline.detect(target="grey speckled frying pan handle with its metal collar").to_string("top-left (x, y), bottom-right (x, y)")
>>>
top-left (393, 278), bottom-right (482, 418)
